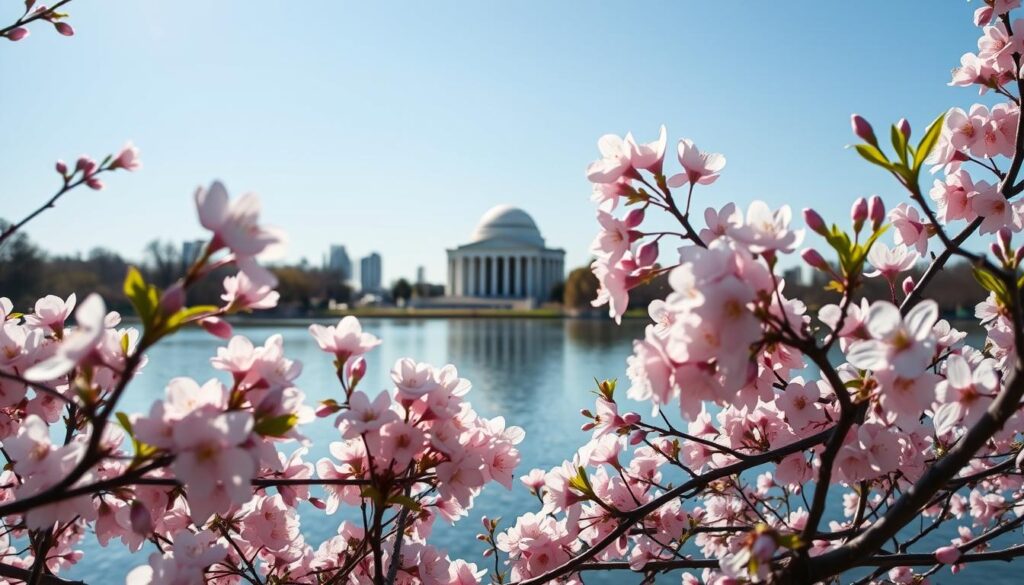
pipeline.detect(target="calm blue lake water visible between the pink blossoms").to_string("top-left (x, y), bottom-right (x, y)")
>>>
top-left (59, 319), bottom-right (1016, 585)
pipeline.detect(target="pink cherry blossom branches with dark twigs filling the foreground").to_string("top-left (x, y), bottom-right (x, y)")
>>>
top-left (6, 0), bottom-right (1024, 585)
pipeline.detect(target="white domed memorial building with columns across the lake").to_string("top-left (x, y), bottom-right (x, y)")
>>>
top-left (447, 205), bottom-right (565, 305)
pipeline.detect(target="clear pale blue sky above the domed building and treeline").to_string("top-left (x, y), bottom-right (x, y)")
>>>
top-left (0, 0), bottom-right (978, 282)
